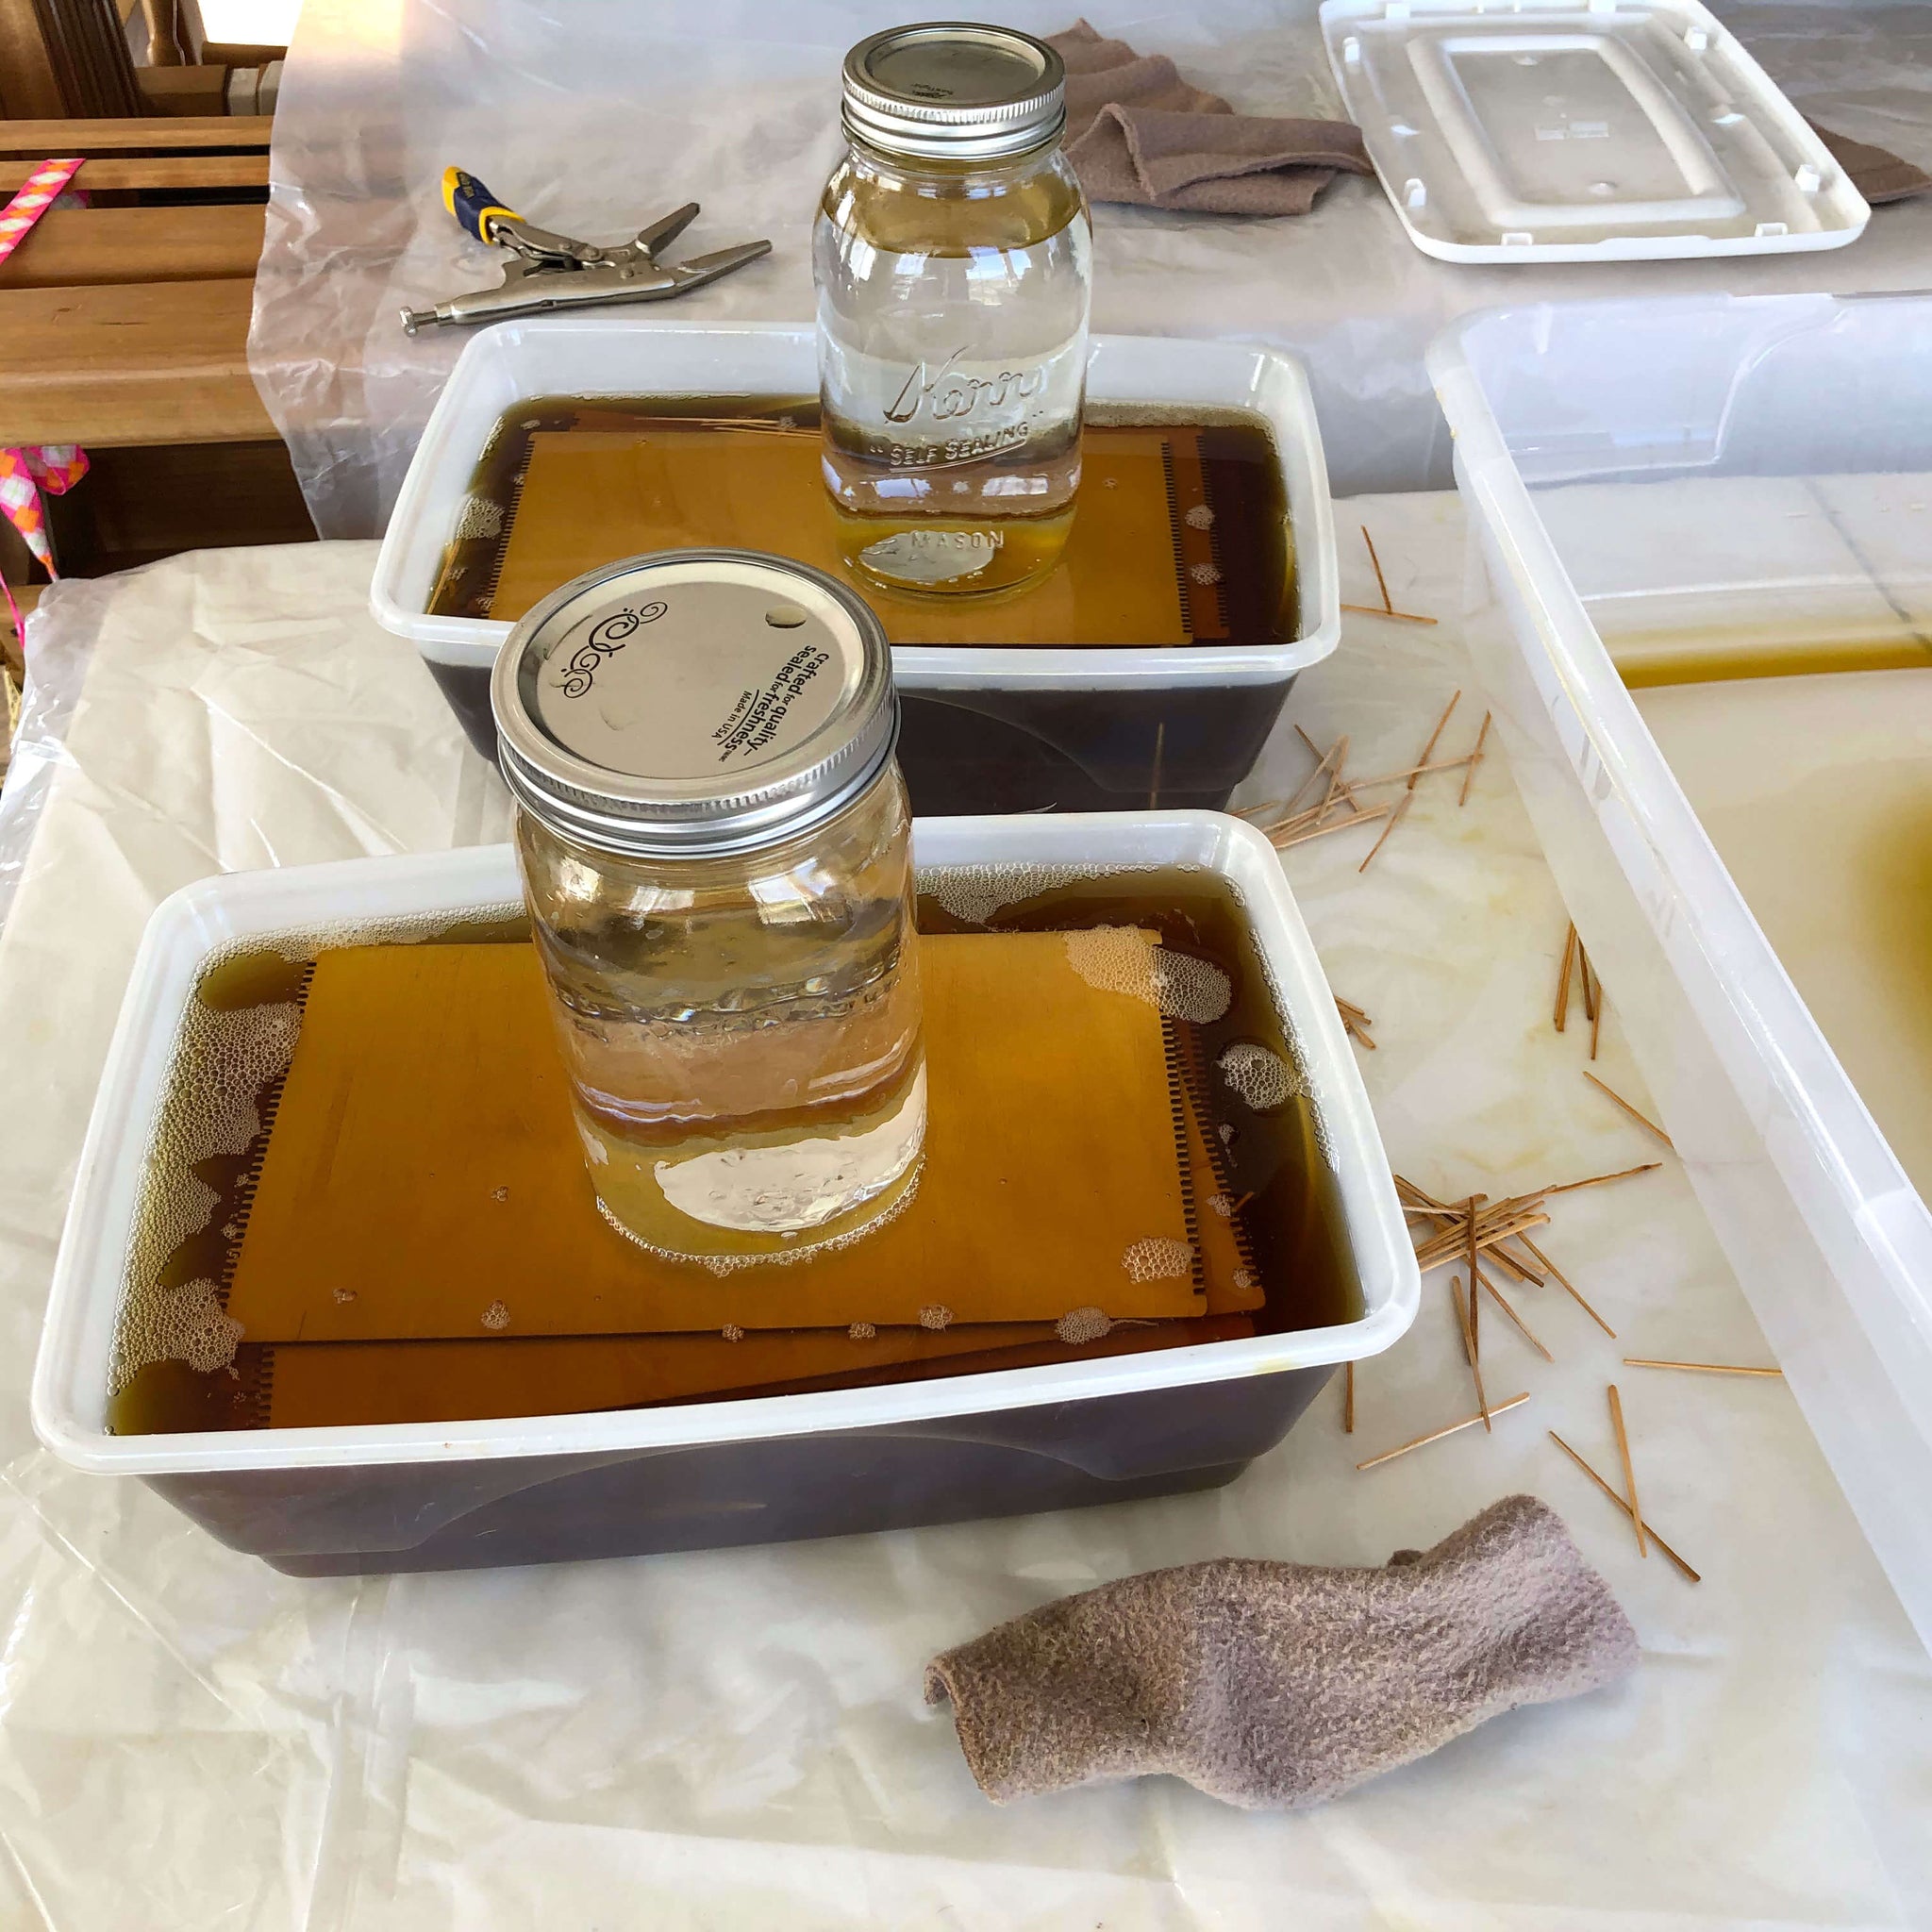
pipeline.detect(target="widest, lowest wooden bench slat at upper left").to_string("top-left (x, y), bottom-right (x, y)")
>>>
top-left (0, 280), bottom-right (276, 446)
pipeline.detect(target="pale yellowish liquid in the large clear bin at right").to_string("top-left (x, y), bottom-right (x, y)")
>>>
top-left (1633, 669), bottom-right (1932, 1198)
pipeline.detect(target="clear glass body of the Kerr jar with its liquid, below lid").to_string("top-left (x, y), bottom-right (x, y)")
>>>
top-left (813, 157), bottom-right (1091, 593)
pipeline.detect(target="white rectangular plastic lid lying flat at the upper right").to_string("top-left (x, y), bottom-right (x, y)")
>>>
top-left (1322, 0), bottom-right (1873, 260)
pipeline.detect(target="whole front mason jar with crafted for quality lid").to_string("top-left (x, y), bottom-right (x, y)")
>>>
top-left (491, 551), bottom-right (925, 1272)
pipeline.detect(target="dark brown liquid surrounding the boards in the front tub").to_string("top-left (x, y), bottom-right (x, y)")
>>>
top-left (110, 868), bottom-right (1360, 1434)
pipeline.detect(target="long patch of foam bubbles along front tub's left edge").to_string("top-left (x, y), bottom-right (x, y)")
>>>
top-left (108, 1001), bottom-right (301, 1395)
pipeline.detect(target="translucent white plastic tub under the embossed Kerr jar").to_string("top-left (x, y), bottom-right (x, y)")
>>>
top-left (371, 315), bottom-right (1341, 813)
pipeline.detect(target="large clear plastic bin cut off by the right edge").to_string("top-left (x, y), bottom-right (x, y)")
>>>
top-left (1430, 295), bottom-right (1932, 1641)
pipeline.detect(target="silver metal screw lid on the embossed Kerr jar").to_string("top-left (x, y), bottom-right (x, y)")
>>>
top-left (844, 19), bottom-right (1066, 160)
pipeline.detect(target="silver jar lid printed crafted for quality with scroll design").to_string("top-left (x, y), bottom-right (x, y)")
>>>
top-left (491, 551), bottom-right (898, 858)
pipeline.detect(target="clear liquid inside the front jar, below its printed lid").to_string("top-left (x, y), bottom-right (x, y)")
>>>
top-left (525, 788), bottom-right (925, 1265)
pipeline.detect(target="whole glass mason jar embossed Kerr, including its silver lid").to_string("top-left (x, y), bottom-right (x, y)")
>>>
top-left (811, 24), bottom-right (1093, 593)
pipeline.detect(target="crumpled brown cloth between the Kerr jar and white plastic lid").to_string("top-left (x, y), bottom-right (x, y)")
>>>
top-left (1049, 19), bottom-right (1375, 214)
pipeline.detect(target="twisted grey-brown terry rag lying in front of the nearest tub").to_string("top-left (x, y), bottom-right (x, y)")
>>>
top-left (925, 1495), bottom-right (1637, 1810)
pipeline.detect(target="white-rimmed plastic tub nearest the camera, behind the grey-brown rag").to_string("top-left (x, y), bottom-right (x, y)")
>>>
top-left (33, 811), bottom-right (1418, 1576)
